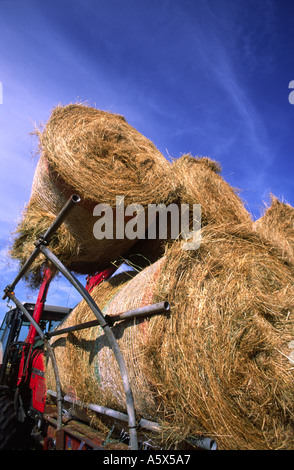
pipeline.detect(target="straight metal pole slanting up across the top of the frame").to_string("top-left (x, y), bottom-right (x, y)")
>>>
top-left (3, 194), bottom-right (80, 300)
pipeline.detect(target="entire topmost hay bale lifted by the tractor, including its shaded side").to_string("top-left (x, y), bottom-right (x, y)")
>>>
top-left (11, 104), bottom-right (175, 285)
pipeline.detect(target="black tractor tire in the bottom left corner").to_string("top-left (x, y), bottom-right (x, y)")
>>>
top-left (0, 395), bottom-right (17, 450)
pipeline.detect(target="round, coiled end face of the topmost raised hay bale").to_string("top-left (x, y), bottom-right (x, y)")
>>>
top-left (39, 104), bottom-right (175, 207)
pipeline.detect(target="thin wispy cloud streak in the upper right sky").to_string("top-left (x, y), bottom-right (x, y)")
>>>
top-left (186, 2), bottom-right (271, 160)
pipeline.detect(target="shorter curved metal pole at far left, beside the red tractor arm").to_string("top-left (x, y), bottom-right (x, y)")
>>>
top-left (7, 292), bottom-right (62, 430)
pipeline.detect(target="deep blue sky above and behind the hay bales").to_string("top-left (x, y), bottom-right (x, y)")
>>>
top-left (0, 0), bottom-right (294, 320)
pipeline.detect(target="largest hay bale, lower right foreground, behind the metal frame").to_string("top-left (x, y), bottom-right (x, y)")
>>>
top-left (46, 224), bottom-right (294, 450)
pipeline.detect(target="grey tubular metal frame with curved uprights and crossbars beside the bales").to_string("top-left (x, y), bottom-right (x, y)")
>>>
top-left (3, 194), bottom-right (169, 450)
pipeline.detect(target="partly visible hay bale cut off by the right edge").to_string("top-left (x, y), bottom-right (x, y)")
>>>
top-left (254, 196), bottom-right (294, 262)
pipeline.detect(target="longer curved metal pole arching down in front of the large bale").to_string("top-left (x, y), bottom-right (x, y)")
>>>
top-left (38, 244), bottom-right (138, 450)
